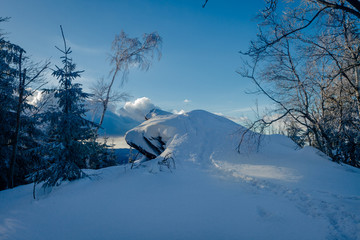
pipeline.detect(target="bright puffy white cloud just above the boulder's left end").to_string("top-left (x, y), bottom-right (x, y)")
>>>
top-left (119, 97), bottom-right (155, 122)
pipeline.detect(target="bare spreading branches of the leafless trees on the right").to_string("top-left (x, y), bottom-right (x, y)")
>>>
top-left (240, 0), bottom-right (360, 166)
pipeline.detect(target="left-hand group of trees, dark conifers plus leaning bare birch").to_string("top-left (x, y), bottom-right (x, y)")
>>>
top-left (0, 18), bottom-right (161, 192)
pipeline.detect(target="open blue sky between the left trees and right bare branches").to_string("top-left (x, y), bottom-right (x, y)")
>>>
top-left (0, 0), bottom-right (267, 122)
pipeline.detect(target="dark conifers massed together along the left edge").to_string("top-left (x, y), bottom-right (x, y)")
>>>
top-left (0, 17), bottom-right (116, 190)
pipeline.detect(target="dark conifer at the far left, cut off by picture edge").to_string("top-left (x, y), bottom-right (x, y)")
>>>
top-left (0, 17), bottom-right (41, 190)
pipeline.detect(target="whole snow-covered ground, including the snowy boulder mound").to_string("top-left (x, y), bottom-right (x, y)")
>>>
top-left (0, 111), bottom-right (360, 240)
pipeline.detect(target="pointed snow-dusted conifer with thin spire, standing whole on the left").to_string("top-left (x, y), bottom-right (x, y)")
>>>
top-left (33, 26), bottom-right (106, 187)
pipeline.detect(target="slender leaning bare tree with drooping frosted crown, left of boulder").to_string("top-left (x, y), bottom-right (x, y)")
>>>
top-left (96, 31), bottom-right (162, 134)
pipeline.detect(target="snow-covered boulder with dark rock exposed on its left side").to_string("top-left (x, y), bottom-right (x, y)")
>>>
top-left (125, 110), bottom-right (264, 167)
